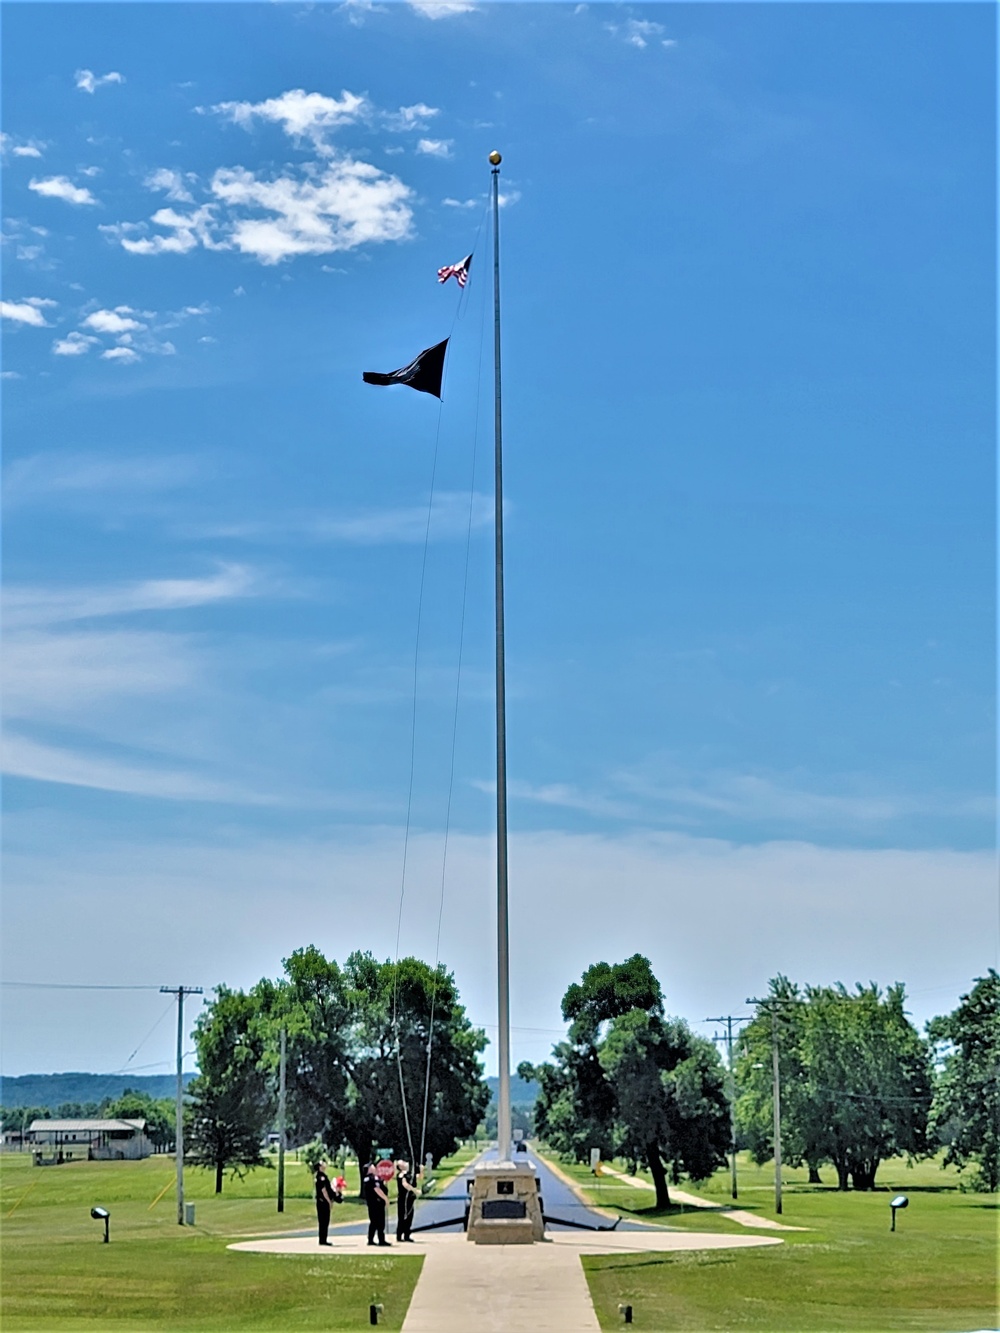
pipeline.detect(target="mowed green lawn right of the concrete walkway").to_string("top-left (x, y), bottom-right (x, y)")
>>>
top-left (544, 1158), bottom-right (1000, 1333)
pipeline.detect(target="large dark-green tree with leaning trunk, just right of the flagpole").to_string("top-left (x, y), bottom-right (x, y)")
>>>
top-left (519, 954), bottom-right (728, 1208)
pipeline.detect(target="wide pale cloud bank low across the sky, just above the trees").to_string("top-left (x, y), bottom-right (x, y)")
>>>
top-left (4, 826), bottom-right (996, 1070)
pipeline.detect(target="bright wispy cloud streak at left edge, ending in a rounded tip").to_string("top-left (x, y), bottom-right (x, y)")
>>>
top-left (3, 565), bottom-right (263, 629)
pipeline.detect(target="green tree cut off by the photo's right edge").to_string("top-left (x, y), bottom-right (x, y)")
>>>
top-left (927, 968), bottom-right (1000, 1192)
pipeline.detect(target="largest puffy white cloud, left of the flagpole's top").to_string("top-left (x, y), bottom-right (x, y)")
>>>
top-left (212, 159), bottom-right (412, 264)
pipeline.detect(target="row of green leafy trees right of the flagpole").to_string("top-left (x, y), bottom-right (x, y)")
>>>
top-left (519, 954), bottom-right (1000, 1208)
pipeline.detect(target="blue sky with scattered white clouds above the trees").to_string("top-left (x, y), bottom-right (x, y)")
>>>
top-left (3, 0), bottom-right (996, 1074)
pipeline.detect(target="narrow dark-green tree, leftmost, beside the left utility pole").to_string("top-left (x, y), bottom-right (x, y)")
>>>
top-left (184, 986), bottom-right (275, 1194)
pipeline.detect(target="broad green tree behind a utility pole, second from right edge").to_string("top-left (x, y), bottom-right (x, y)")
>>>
top-left (737, 977), bottom-right (932, 1189)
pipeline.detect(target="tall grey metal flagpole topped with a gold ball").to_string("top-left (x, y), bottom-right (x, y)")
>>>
top-left (489, 151), bottom-right (511, 1161)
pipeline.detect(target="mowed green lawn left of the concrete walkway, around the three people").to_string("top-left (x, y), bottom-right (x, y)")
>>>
top-left (0, 1153), bottom-right (423, 1333)
